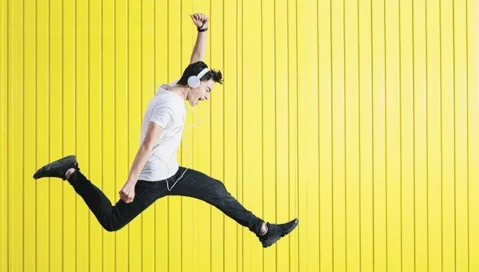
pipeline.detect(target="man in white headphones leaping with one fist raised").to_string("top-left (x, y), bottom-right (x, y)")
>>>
top-left (33, 13), bottom-right (298, 250)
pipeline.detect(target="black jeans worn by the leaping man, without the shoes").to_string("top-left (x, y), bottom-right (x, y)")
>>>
top-left (68, 167), bottom-right (264, 234)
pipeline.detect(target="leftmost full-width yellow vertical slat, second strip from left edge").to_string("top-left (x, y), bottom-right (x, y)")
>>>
top-left (6, 1), bottom-right (24, 270)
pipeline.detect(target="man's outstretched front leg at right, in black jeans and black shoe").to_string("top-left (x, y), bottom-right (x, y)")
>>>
top-left (167, 167), bottom-right (298, 247)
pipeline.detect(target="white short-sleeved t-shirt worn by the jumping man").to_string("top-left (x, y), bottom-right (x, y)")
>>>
top-left (139, 81), bottom-right (186, 181)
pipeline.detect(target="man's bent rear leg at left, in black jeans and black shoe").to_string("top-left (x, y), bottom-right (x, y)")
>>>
top-left (34, 156), bottom-right (166, 231)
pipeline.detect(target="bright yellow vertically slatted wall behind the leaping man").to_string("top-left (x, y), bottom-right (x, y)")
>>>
top-left (0, 0), bottom-right (479, 272)
